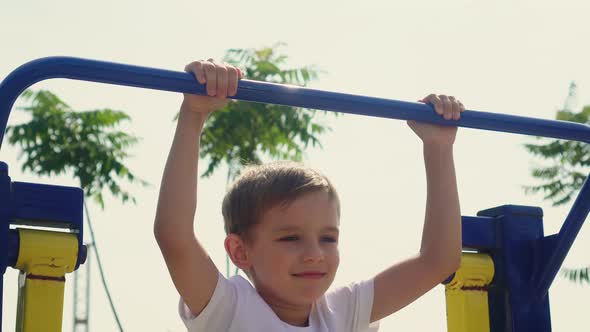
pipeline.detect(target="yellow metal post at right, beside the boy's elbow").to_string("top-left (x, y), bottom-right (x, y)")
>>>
top-left (445, 253), bottom-right (494, 332)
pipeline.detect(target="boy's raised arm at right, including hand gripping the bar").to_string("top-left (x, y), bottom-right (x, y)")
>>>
top-left (370, 95), bottom-right (464, 322)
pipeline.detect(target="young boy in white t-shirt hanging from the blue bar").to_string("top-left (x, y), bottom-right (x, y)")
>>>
top-left (154, 59), bottom-right (464, 332)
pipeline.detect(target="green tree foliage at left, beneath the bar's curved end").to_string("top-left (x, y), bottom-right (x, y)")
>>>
top-left (6, 90), bottom-right (147, 208)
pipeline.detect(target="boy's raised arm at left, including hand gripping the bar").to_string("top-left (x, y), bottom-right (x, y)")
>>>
top-left (154, 59), bottom-right (241, 315)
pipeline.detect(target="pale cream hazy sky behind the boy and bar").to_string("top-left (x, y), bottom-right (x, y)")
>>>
top-left (0, 0), bottom-right (590, 332)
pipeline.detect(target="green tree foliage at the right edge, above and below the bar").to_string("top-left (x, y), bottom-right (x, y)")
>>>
top-left (524, 84), bottom-right (590, 206)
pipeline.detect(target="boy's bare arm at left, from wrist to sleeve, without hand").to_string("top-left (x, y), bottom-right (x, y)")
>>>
top-left (154, 110), bottom-right (218, 315)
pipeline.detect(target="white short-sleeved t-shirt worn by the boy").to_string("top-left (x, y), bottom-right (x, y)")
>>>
top-left (179, 274), bottom-right (379, 332)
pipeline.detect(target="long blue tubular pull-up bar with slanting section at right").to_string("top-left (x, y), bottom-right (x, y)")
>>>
top-left (0, 57), bottom-right (590, 300)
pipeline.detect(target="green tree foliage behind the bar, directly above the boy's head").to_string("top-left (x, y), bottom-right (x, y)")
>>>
top-left (192, 44), bottom-right (338, 177)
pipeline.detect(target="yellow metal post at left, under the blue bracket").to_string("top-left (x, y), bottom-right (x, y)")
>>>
top-left (15, 229), bottom-right (78, 332)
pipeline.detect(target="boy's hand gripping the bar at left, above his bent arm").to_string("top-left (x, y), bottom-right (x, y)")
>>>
top-left (181, 58), bottom-right (243, 115)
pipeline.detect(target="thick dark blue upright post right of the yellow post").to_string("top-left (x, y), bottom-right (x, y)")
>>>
top-left (477, 205), bottom-right (551, 332)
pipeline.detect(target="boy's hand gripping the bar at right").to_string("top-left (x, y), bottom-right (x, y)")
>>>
top-left (408, 94), bottom-right (465, 145)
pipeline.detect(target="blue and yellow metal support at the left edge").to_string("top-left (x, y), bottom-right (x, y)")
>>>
top-left (0, 166), bottom-right (86, 332)
